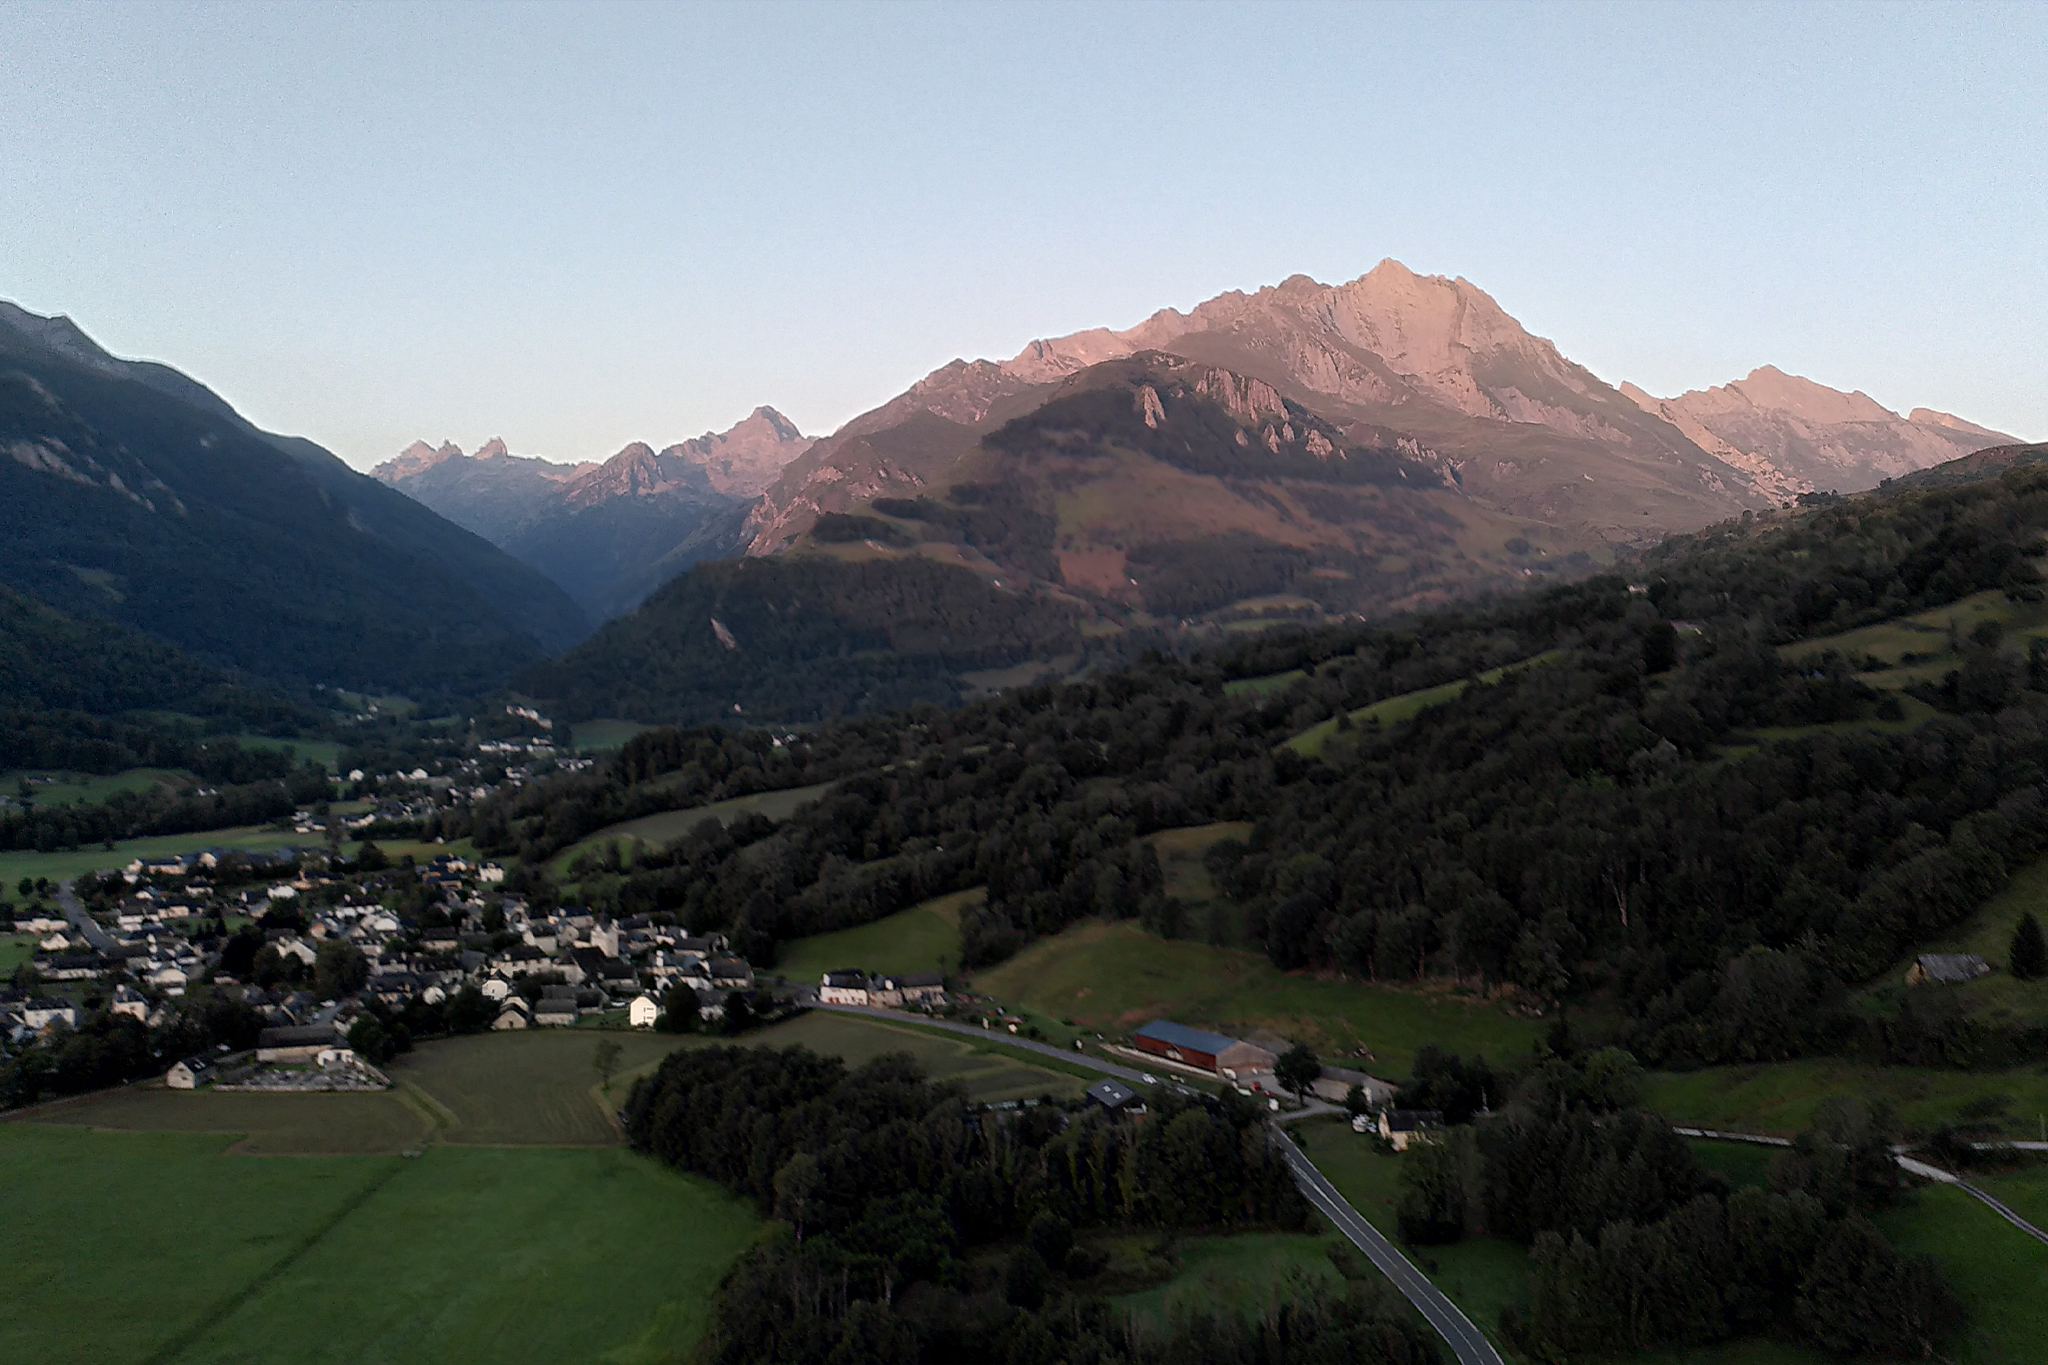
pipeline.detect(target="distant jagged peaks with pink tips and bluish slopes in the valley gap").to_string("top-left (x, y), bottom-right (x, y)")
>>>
top-left (373, 407), bottom-right (811, 618)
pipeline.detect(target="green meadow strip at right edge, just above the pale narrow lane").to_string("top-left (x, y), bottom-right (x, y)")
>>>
top-left (1642, 1058), bottom-right (2048, 1136)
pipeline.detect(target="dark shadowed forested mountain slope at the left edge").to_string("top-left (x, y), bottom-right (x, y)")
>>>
top-left (0, 303), bottom-right (588, 694)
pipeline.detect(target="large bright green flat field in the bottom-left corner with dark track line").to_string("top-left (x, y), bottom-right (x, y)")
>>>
top-left (0, 1129), bottom-right (758, 1365)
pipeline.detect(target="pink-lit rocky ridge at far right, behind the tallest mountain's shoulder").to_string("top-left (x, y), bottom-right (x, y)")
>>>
top-left (1622, 364), bottom-right (2015, 493)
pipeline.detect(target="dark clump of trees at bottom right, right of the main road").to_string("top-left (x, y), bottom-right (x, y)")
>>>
top-left (1399, 1050), bottom-right (1962, 1361)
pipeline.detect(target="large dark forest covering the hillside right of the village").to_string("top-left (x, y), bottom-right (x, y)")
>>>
top-left (464, 469), bottom-right (2048, 1064)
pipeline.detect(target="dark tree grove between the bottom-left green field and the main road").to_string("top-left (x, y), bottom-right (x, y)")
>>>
top-left (625, 1048), bottom-right (1442, 1365)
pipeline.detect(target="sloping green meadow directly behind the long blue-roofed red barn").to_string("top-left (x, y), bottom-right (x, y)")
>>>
top-left (973, 919), bottom-right (1544, 1076)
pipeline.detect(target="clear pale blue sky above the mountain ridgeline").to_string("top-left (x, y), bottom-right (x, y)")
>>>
top-left (0, 2), bottom-right (2048, 467)
